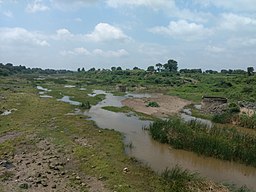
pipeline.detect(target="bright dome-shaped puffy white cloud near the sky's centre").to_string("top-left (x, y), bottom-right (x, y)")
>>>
top-left (85, 23), bottom-right (129, 42)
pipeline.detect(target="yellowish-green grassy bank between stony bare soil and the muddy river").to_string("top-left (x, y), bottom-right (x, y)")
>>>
top-left (0, 76), bottom-right (206, 192)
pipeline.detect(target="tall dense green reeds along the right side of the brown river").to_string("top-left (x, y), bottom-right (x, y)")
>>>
top-left (149, 117), bottom-right (256, 167)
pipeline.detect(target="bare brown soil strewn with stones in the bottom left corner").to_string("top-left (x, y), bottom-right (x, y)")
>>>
top-left (0, 134), bottom-right (108, 192)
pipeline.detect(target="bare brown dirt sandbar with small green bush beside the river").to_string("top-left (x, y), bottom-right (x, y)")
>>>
top-left (122, 94), bottom-right (191, 117)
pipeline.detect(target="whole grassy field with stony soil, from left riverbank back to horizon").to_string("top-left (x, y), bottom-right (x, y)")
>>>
top-left (0, 70), bottom-right (255, 192)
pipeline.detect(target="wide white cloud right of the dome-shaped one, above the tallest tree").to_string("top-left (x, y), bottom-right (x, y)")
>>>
top-left (149, 20), bottom-right (212, 41)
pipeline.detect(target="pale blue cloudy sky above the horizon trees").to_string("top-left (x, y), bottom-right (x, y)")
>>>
top-left (0, 0), bottom-right (256, 70)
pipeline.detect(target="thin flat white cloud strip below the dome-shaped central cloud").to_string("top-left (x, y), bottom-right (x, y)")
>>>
top-left (60, 47), bottom-right (129, 57)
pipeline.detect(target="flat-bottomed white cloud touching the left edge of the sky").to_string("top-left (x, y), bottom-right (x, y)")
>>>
top-left (0, 27), bottom-right (49, 46)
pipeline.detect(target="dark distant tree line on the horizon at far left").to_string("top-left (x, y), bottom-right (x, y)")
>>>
top-left (0, 63), bottom-right (72, 76)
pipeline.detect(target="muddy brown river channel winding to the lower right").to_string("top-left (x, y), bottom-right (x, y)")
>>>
top-left (85, 93), bottom-right (256, 190)
